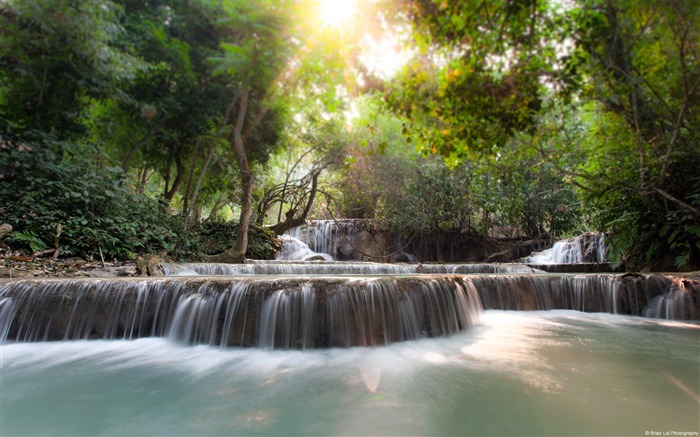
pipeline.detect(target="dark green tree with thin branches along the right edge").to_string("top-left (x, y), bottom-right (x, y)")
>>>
top-left (569, 0), bottom-right (700, 267)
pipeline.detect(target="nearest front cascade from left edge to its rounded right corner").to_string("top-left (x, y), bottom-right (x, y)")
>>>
top-left (0, 276), bottom-right (482, 349)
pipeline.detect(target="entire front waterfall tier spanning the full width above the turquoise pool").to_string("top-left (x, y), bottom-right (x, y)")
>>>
top-left (0, 270), bottom-right (700, 349)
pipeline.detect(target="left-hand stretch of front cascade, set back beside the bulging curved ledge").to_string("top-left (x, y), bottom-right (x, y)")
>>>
top-left (0, 280), bottom-right (184, 342)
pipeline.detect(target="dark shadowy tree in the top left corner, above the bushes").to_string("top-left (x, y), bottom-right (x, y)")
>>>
top-left (0, 0), bottom-right (146, 141)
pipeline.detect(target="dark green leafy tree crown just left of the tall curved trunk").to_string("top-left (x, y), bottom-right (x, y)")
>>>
top-left (94, 0), bottom-right (234, 209)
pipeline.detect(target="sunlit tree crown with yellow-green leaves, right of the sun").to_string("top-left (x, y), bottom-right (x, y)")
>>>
top-left (386, 0), bottom-right (562, 165)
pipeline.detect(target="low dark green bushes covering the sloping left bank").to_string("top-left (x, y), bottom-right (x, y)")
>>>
top-left (0, 143), bottom-right (279, 261)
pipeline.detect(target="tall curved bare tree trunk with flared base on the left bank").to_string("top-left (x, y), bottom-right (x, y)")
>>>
top-left (207, 88), bottom-right (253, 263)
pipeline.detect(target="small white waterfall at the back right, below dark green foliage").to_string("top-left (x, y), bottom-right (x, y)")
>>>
top-left (522, 232), bottom-right (606, 264)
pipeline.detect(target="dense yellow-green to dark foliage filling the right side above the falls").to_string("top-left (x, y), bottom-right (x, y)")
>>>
top-left (370, 0), bottom-right (700, 268)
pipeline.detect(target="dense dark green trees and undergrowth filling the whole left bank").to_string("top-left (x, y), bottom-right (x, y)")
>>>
top-left (0, 0), bottom-right (281, 258)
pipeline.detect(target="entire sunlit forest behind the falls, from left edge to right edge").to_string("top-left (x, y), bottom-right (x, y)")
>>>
top-left (0, 0), bottom-right (700, 269)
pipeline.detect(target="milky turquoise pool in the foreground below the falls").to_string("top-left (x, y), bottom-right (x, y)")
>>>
top-left (0, 311), bottom-right (700, 436)
